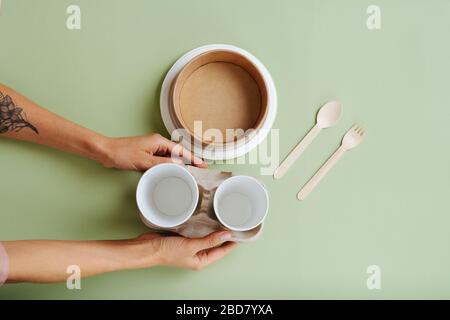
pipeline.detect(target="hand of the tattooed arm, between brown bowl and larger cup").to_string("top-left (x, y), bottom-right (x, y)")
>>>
top-left (100, 134), bottom-right (207, 171)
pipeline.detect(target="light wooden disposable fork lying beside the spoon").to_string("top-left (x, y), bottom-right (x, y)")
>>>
top-left (297, 125), bottom-right (365, 200)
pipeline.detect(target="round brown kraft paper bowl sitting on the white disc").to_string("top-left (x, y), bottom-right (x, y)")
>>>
top-left (169, 50), bottom-right (269, 146)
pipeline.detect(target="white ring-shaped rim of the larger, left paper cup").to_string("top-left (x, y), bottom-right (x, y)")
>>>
top-left (136, 163), bottom-right (200, 228)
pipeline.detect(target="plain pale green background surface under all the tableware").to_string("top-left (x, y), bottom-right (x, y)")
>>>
top-left (0, 0), bottom-right (450, 299)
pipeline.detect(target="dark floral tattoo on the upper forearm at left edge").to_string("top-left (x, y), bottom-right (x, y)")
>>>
top-left (0, 92), bottom-right (39, 134)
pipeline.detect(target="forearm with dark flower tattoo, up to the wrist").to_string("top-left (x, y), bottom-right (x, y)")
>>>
top-left (0, 84), bottom-right (107, 162)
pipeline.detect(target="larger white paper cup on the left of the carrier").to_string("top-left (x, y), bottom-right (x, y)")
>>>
top-left (136, 163), bottom-right (199, 228)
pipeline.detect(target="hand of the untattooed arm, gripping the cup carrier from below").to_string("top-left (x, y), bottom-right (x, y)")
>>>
top-left (134, 231), bottom-right (236, 270)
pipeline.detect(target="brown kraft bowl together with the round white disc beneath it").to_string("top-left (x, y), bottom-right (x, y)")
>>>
top-left (160, 45), bottom-right (277, 160)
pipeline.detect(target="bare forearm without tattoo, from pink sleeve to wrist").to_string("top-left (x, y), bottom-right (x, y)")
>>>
top-left (3, 240), bottom-right (158, 283)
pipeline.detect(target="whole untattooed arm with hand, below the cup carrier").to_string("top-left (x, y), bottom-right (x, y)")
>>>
top-left (0, 232), bottom-right (236, 283)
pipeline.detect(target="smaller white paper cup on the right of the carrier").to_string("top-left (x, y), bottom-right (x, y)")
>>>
top-left (214, 176), bottom-right (269, 231)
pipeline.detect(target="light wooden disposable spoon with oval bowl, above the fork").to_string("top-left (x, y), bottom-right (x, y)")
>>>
top-left (273, 101), bottom-right (342, 179)
